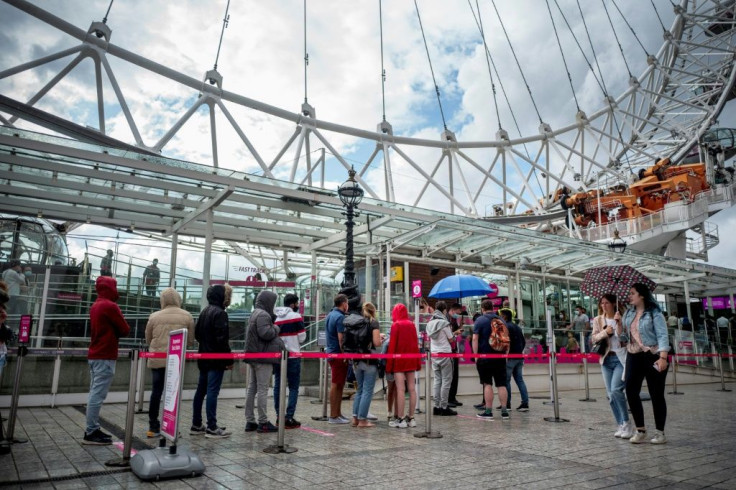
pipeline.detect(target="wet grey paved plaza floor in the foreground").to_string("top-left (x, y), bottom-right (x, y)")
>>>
top-left (0, 384), bottom-right (736, 489)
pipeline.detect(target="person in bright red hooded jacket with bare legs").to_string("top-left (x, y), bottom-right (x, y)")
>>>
top-left (386, 303), bottom-right (422, 429)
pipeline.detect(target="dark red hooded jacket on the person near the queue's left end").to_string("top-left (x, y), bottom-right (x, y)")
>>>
top-left (87, 276), bottom-right (130, 361)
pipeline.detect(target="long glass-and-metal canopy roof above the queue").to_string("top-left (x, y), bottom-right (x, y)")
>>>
top-left (0, 128), bottom-right (736, 294)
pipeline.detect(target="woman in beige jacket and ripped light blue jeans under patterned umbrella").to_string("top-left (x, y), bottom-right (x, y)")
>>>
top-left (591, 294), bottom-right (634, 439)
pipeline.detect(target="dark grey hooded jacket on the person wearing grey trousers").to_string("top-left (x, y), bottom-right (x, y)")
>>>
top-left (245, 291), bottom-right (284, 364)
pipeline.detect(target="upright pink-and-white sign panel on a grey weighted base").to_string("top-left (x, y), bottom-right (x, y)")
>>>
top-left (161, 329), bottom-right (187, 442)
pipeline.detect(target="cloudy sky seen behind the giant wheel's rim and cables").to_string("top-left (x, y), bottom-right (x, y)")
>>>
top-left (0, 0), bottom-right (736, 276)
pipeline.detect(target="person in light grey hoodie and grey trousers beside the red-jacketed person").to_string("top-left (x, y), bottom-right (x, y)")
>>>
top-left (427, 301), bottom-right (457, 416)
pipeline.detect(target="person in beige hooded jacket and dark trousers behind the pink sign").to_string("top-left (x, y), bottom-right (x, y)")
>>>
top-left (146, 288), bottom-right (194, 438)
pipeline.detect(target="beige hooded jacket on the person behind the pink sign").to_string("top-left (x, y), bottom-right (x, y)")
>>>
top-left (146, 288), bottom-right (194, 369)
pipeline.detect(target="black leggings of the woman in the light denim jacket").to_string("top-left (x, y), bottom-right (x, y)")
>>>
top-left (626, 352), bottom-right (670, 431)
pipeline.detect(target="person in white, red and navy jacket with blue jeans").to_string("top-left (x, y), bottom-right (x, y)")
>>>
top-left (273, 293), bottom-right (307, 429)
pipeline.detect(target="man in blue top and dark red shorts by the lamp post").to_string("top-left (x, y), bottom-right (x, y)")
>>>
top-left (325, 293), bottom-right (350, 424)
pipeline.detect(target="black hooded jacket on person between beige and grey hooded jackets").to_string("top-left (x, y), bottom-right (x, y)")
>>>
top-left (194, 284), bottom-right (233, 370)
